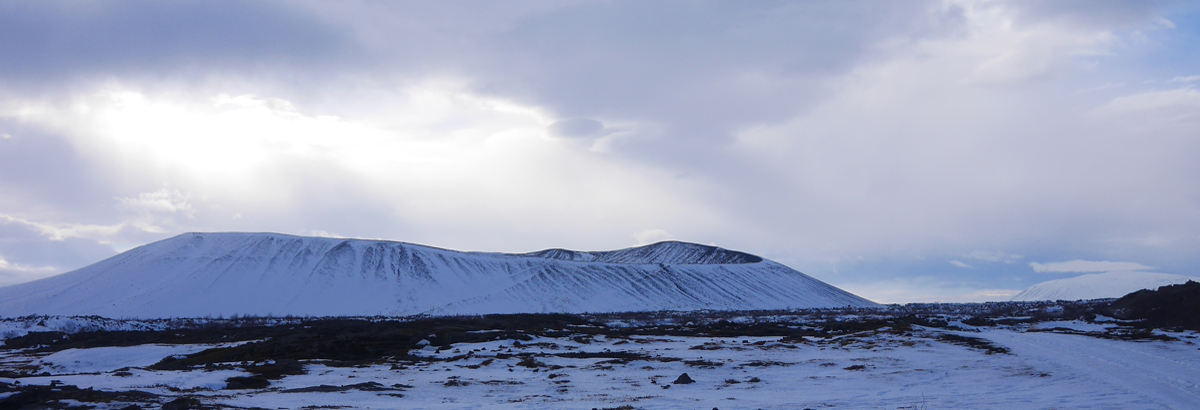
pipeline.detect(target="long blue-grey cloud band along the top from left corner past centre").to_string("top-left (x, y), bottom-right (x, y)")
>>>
top-left (0, 0), bottom-right (961, 133)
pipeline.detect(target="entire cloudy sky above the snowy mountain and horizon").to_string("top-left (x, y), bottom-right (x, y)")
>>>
top-left (0, 0), bottom-right (1200, 302)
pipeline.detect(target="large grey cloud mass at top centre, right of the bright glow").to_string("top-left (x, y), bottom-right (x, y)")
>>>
top-left (472, 1), bottom-right (958, 140)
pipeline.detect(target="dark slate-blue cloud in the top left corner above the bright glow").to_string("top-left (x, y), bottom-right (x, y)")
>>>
top-left (0, 1), bottom-right (352, 86)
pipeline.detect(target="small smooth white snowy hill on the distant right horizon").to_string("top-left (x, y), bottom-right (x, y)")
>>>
top-left (1013, 272), bottom-right (1200, 301)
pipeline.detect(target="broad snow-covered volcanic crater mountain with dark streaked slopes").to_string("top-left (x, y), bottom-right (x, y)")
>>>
top-left (0, 233), bottom-right (875, 318)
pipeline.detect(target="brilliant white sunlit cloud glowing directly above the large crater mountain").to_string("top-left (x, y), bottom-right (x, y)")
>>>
top-left (2, 82), bottom-right (719, 251)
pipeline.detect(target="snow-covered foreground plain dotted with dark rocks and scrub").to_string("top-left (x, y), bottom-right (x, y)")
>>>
top-left (0, 311), bottom-right (1200, 409)
